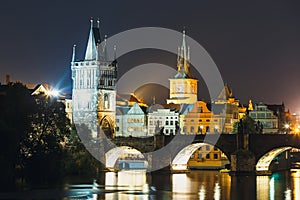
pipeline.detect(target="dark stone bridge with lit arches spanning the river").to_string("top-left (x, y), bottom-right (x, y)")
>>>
top-left (106, 134), bottom-right (300, 174)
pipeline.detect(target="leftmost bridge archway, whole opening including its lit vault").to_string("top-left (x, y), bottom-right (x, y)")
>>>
top-left (105, 146), bottom-right (148, 171)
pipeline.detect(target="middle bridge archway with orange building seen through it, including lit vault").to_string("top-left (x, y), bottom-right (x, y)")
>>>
top-left (171, 143), bottom-right (230, 171)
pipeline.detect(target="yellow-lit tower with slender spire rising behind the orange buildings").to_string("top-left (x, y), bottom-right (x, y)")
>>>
top-left (167, 31), bottom-right (198, 104)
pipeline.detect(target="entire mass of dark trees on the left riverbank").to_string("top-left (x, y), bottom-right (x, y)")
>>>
top-left (0, 83), bottom-right (103, 190)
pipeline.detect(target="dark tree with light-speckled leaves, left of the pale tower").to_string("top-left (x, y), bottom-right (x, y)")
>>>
top-left (21, 95), bottom-right (71, 182)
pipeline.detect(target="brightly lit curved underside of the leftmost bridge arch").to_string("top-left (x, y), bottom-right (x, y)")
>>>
top-left (105, 146), bottom-right (145, 171)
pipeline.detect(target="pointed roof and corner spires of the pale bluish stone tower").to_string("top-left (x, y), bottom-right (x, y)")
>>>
top-left (72, 19), bottom-right (116, 62)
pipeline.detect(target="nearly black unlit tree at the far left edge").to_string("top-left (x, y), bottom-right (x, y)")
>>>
top-left (0, 83), bottom-right (35, 189)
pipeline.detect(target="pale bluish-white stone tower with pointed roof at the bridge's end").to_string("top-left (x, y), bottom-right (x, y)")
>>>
top-left (71, 19), bottom-right (117, 138)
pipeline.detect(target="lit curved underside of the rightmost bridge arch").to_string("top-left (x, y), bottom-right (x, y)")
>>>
top-left (256, 146), bottom-right (293, 173)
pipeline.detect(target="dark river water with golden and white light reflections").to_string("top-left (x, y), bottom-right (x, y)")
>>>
top-left (0, 170), bottom-right (300, 200)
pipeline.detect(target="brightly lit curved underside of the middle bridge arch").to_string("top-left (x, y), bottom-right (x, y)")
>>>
top-left (170, 142), bottom-right (229, 171)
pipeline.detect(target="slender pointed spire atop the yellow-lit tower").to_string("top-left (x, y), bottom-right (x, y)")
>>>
top-left (175, 30), bottom-right (192, 78)
